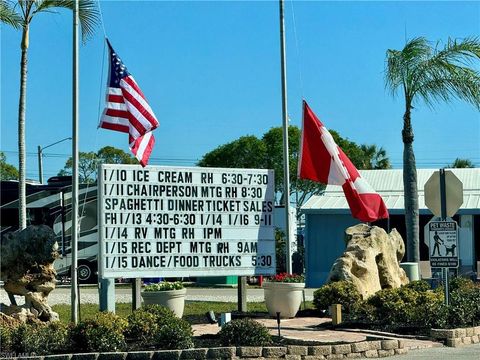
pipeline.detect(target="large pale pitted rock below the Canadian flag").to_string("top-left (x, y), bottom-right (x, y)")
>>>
top-left (327, 224), bottom-right (408, 299)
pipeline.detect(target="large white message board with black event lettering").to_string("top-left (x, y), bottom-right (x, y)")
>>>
top-left (98, 164), bottom-right (275, 278)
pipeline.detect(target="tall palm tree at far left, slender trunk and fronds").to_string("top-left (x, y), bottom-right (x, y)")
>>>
top-left (0, 0), bottom-right (99, 229)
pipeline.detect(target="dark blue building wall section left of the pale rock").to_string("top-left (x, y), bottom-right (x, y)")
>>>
top-left (305, 214), bottom-right (359, 288)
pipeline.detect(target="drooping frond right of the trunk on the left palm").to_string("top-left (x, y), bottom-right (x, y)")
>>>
top-left (34, 0), bottom-right (100, 42)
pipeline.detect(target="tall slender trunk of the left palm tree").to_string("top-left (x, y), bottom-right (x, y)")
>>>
top-left (18, 24), bottom-right (29, 230)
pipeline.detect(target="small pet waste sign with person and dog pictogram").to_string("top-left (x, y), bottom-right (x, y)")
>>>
top-left (425, 220), bottom-right (458, 268)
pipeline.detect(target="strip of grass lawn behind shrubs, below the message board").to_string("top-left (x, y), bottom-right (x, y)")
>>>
top-left (52, 301), bottom-right (313, 324)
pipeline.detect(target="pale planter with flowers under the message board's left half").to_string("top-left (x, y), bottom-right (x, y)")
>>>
top-left (142, 281), bottom-right (187, 318)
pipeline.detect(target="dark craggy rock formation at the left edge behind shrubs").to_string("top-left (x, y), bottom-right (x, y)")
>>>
top-left (0, 225), bottom-right (58, 321)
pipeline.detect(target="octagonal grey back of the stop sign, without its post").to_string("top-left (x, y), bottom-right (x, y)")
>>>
top-left (424, 170), bottom-right (463, 216)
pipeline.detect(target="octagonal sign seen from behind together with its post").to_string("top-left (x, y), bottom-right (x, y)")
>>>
top-left (424, 169), bottom-right (463, 305)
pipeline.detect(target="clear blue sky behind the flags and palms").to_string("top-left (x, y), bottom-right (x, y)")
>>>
top-left (0, 1), bottom-right (480, 179)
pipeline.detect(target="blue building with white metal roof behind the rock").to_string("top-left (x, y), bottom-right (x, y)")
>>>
top-left (301, 168), bottom-right (480, 287)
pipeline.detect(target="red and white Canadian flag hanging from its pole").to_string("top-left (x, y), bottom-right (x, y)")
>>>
top-left (298, 101), bottom-right (388, 222)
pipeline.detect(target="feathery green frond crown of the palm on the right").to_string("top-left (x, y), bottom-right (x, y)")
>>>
top-left (385, 37), bottom-right (480, 109)
